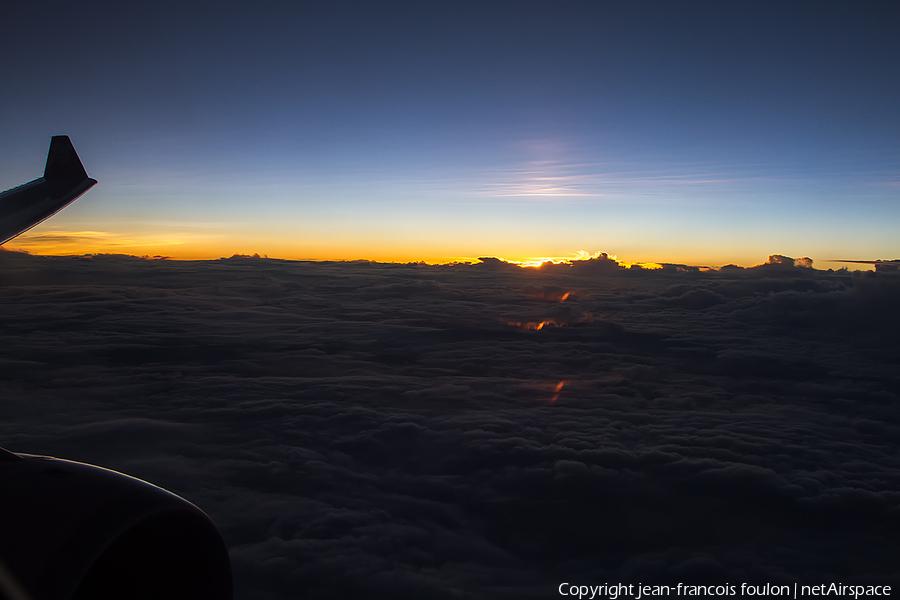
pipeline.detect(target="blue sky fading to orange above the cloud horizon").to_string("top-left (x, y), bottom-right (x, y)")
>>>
top-left (0, 2), bottom-right (900, 267)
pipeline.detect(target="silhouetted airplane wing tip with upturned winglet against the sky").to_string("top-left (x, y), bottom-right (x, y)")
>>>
top-left (0, 135), bottom-right (97, 245)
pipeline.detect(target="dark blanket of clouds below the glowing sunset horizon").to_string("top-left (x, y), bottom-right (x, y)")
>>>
top-left (0, 252), bottom-right (900, 599)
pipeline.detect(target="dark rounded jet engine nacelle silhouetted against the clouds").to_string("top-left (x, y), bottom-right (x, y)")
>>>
top-left (0, 449), bottom-right (232, 600)
